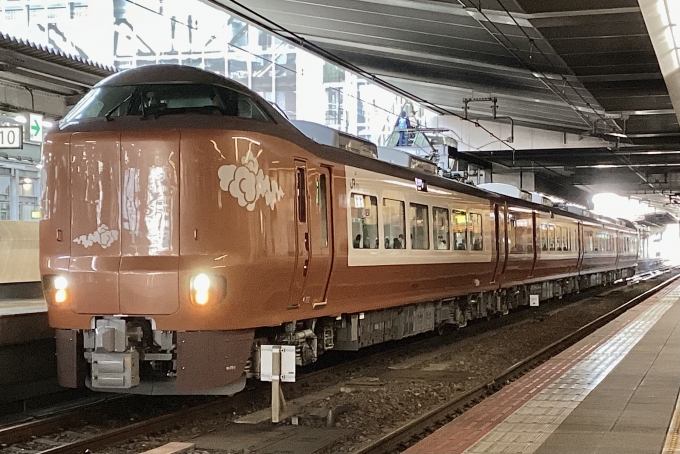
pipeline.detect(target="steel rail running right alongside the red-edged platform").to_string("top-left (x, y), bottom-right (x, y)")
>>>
top-left (354, 274), bottom-right (680, 454)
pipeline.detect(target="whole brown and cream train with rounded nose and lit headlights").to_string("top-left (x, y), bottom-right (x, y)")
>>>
top-left (40, 66), bottom-right (637, 394)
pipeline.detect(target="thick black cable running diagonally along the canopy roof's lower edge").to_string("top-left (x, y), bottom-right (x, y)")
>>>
top-left (208, 0), bottom-right (517, 152)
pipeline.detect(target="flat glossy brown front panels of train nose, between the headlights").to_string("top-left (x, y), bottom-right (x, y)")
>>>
top-left (69, 131), bottom-right (179, 315)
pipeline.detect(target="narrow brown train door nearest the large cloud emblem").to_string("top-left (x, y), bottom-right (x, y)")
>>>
top-left (288, 159), bottom-right (311, 309)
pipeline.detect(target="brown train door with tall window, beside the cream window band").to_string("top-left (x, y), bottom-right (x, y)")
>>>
top-left (304, 166), bottom-right (333, 309)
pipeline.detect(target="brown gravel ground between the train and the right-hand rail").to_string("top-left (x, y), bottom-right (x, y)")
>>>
top-left (0, 274), bottom-right (669, 454)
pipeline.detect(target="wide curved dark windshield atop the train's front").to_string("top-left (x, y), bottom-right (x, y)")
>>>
top-left (62, 84), bottom-right (271, 123)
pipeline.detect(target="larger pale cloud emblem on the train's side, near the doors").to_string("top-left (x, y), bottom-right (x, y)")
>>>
top-left (216, 137), bottom-right (284, 211)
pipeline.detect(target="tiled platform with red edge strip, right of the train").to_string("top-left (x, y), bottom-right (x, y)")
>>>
top-left (405, 281), bottom-right (680, 454)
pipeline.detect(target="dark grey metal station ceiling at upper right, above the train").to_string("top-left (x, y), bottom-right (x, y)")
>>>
top-left (216, 0), bottom-right (680, 213)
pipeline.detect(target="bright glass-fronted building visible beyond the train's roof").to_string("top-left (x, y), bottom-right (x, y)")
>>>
top-left (0, 0), bottom-right (422, 143)
